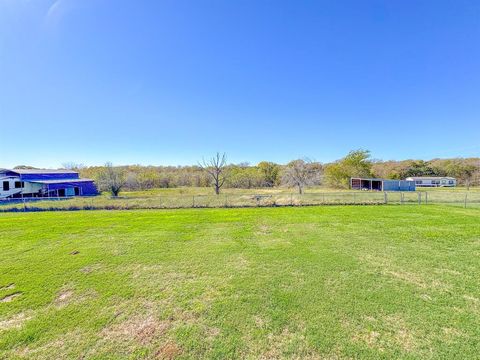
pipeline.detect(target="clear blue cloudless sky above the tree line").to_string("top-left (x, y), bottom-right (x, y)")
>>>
top-left (0, 0), bottom-right (480, 167)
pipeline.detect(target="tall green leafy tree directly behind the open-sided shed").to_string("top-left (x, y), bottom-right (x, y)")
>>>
top-left (325, 150), bottom-right (373, 188)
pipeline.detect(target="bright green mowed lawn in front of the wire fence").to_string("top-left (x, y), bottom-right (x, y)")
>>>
top-left (0, 205), bottom-right (480, 359)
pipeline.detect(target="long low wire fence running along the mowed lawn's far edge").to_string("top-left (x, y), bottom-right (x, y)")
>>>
top-left (0, 191), bottom-right (480, 212)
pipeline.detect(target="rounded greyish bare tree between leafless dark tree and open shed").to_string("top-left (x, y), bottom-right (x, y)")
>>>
top-left (282, 159), bottom-right (322, 194)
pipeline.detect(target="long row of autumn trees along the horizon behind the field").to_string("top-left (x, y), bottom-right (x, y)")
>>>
top-left (57, 150), bottom-right (480, 196)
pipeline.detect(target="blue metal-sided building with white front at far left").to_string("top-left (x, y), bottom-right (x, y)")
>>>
top-left (0, 169), bottom-right (98, 198)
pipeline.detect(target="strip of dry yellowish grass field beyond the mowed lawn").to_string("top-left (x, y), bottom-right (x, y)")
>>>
top-left (0, 187), bottom-right (480, 212)
